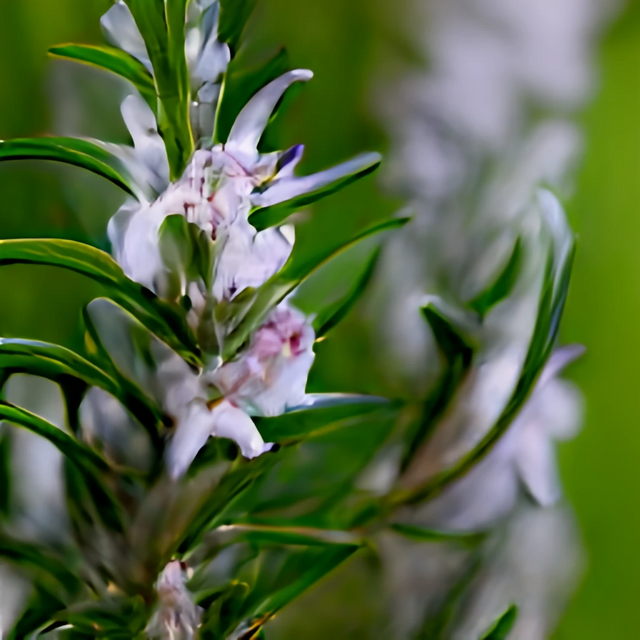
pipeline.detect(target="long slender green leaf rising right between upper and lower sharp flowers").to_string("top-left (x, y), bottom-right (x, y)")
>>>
top-left (222, 218), bottom-right (409, 360)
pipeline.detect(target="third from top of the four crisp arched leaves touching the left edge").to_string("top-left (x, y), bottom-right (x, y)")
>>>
top-left (0, 338), bottom-right (163, 442)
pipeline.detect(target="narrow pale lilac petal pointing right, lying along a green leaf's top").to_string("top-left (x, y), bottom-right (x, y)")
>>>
top-left (252, 153), bottom-right (381, 207)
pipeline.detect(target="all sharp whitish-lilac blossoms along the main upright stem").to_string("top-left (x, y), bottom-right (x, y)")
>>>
top-left (87, 0), bottom-right (380, 477)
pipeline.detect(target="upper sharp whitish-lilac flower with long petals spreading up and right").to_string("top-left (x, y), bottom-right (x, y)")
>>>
top-left (109, 70), bottom-right (379, 316)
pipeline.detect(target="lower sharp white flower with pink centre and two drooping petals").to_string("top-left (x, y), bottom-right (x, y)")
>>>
top-left (166, 303), bottom-right (315, 477)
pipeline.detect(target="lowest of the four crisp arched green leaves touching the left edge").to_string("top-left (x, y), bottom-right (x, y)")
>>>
top-left (0, 401), bottom-right (110, 472)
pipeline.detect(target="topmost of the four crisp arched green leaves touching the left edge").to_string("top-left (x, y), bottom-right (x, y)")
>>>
top-left (0, 138), bottom-right (148, 200)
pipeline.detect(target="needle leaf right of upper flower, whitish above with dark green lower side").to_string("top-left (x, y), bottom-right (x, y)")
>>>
top-left (249, 153), bottom-right (382, 231)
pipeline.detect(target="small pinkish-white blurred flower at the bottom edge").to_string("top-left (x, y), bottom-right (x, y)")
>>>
top-left (146, 561), bottom-right (202, 640)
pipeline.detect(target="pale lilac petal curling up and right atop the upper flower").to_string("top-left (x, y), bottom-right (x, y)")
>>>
top-left (226, 69), bottom-right (313, 162)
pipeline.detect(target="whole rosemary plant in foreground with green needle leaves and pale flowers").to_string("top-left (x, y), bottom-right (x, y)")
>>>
top-left (0, 0), bottom-right (574, 640)
